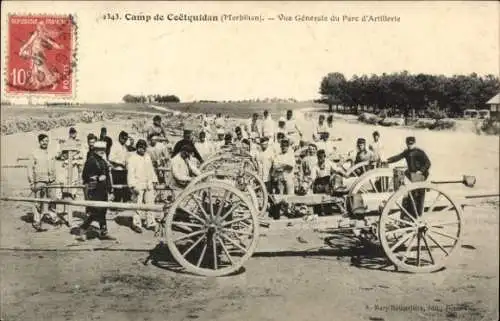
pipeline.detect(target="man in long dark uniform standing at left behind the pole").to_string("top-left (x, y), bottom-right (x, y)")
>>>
top-left (80, 141), bottom-right (115, 240)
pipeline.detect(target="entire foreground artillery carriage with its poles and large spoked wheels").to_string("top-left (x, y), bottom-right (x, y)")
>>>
top-left (2, 141), bottom-right (498, 276)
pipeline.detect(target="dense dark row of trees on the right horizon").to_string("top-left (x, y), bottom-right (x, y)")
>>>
top-left (318, 71), bottom-right (500, 116)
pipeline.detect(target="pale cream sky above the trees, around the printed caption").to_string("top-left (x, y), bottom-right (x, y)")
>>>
top-left (1, 1), bottom-right (500, 103)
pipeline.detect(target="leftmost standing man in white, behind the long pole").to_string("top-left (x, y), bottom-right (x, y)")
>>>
top-left (28, 134), bottom-right (61, 232)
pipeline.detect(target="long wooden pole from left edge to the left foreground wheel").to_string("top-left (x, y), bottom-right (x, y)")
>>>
top-left (0, 196), bottom-right (163, 212)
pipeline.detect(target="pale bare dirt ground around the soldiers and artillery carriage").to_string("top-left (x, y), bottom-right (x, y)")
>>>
top-left (0, 110), bottom-right (499, 321)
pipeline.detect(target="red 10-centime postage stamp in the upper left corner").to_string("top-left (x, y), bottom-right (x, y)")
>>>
top-left (6, 15), bottom-right (76, 96)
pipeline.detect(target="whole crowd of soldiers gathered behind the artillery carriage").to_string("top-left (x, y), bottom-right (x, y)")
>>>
top-left (24, 110), bottom-right (430, 240)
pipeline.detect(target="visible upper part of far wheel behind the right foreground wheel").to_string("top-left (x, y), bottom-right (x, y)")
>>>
top-left (349, 168), bottom-right (394, 196)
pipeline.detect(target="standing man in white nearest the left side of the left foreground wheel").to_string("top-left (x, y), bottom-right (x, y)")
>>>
top-left (127, 139), bottom-right (158, 233)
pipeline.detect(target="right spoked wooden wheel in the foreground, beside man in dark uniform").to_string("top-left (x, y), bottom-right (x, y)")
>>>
top-left (379, 182), bottom-right (462, 272)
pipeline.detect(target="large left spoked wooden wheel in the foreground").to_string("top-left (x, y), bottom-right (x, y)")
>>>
top-left (166, 182), bottom-right (259, 276)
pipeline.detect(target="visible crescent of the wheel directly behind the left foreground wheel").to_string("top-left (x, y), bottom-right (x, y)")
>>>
top-left (190, 170), bottom-right (269, 217)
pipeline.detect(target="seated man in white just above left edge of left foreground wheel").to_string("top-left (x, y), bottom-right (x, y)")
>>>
top-left (171, 145), bottom-right (200, 190)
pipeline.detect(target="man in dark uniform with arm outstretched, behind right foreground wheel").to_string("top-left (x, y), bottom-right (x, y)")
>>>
top-left (387, 136), bottom-right (431, 217)
